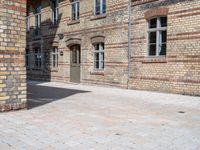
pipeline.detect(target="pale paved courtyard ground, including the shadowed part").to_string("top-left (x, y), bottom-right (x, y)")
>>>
top-left (0, 82), bottom-right (200, 150)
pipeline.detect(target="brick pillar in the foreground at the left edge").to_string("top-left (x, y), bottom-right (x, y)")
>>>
top-left (0, 0), bottom-right (27, 112)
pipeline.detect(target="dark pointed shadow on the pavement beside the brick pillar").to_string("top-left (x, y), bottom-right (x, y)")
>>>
top-left (28, 84), bottom-right (90, 109)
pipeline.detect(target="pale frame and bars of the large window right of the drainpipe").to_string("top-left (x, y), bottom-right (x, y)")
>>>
top-left (148, 16), bottom-right (167, 57)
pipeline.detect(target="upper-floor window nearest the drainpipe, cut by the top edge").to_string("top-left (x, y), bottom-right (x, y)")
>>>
top-left (94, 0), bottom-right (106, 15)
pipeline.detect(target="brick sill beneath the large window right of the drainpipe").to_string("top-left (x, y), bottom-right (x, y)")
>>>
top-left (142, 56), bottom-right (167, 63)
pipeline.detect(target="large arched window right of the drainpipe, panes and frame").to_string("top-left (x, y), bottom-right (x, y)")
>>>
top-left (148, 17), bottom-right (167, 56)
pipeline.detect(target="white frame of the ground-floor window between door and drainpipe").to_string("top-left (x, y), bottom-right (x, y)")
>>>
top-left (93, 43), bottom-right (105, 71)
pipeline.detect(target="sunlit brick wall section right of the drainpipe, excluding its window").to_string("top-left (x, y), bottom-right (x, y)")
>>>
top-left (131, 0), bottom-right (200, 95)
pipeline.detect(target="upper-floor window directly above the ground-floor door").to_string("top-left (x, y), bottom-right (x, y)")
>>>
top-left (71, 0), bottom-right (79, 20)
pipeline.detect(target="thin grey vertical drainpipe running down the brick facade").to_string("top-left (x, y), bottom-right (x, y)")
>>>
top-left (127, 0), bottom-right (131, 89)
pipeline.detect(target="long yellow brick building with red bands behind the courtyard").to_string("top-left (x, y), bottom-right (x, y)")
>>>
top-left (26, 0), bottom-right (200, 95)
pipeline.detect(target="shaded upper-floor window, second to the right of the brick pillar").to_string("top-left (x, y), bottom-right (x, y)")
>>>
top-left (35, 6), bottom-right (41, 36)
